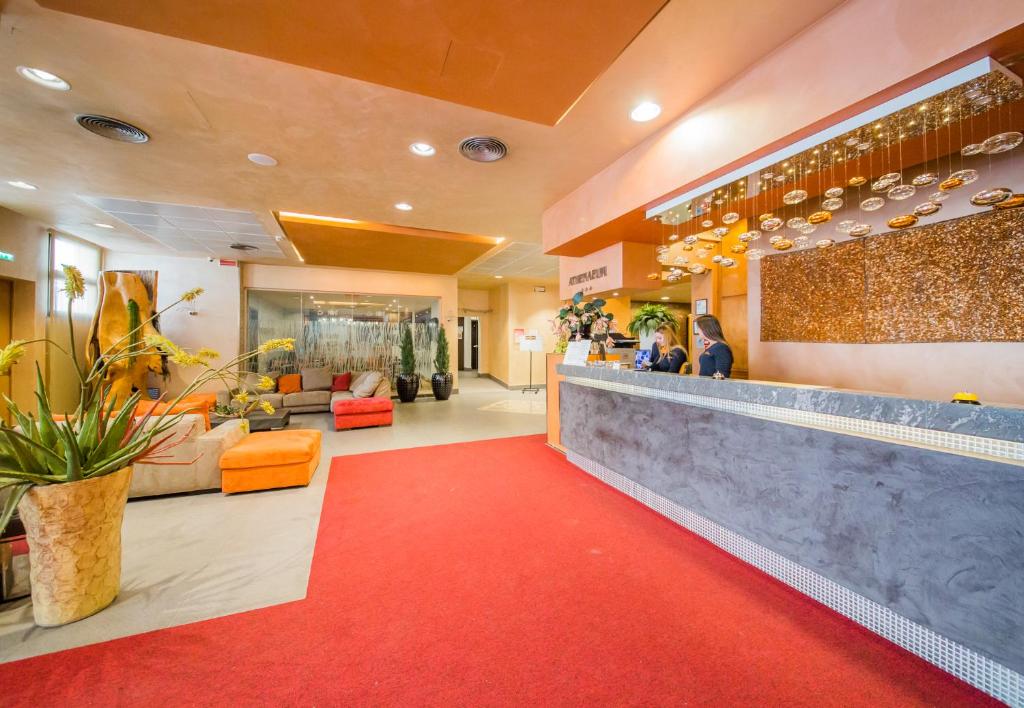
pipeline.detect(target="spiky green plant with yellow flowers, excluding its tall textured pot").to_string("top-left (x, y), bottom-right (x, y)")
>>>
top-left (0, 265), bottom-right (295, 532)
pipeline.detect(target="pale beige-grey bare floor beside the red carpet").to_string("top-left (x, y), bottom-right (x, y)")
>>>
top-left (0, 377), bottom-right (545, 662)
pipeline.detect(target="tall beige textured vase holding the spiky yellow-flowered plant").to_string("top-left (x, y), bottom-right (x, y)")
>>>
top-left (17, 467), bottom-right (131, 627)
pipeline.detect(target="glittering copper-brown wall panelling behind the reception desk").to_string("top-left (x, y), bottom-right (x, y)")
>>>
top-left (761, 209), bottom-right (1024, 343)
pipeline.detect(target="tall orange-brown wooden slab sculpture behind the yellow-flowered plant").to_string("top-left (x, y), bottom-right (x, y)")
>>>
top-left (88, 270), bottom-right (164, 408)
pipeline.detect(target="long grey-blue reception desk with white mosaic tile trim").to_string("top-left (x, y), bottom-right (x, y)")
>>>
top-left (558, 365), bottom-right (1024, 705)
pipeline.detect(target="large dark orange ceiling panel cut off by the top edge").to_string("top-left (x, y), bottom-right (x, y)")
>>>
top-left (39, 0), bottom-right (668, 125)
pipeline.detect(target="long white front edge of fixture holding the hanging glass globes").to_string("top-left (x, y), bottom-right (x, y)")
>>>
top-left (645, 56), bottom-right (1021, 218)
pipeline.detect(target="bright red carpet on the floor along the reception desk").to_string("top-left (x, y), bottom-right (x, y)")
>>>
top-left (0, 436), bottom-right (994, 708)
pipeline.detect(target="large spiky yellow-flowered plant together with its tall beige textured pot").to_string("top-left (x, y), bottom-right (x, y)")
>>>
top-left (0, 265), bottom-right (294, 626)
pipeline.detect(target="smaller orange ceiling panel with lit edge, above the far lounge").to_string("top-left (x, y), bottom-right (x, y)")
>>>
top-left (278, 214), bottom-right (497, 276)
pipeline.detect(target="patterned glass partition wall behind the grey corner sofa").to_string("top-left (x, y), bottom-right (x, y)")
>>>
top-left (245, 288), bottom-right (440, 383)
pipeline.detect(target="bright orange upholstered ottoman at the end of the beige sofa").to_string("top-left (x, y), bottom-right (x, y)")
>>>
top-left (220, 430), bottom-right (321, 494)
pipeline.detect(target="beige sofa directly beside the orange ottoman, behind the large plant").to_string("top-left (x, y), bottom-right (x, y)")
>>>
top-left (128, 415), bottom-right (249, 498)
